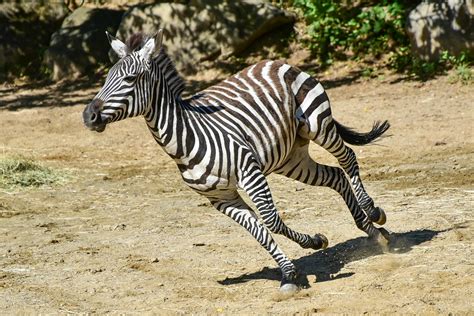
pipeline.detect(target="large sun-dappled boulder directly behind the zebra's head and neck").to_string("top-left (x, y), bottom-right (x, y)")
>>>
top-left (116, 0), bottom-right (294, 74)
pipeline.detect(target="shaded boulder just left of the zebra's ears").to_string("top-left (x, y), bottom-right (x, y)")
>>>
top-left (43, 7), bottom-right (124, 81)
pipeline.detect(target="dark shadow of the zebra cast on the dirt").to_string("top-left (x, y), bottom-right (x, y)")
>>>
top-left (218, 229), bottom-right (451, 288)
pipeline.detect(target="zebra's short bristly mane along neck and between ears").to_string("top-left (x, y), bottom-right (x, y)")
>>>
top-left (126, 32), bottom-right (186, 98)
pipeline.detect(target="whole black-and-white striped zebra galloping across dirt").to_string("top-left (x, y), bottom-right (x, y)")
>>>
top-left (83, 30), bottom-right (390, 292)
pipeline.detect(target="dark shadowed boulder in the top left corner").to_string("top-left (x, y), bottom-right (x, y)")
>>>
top-left (0, 1), bottom-right (68, 81)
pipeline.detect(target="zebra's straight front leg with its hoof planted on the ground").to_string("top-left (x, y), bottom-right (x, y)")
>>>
top-left (209, 192), bottom-right (298, 292)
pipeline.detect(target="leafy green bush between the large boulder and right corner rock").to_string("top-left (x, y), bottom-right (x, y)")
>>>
top-left (290, 0), bottom-right (408, 64)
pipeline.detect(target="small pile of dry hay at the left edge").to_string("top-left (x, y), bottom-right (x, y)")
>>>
top-left (0, 157), bottom-right (68, 189)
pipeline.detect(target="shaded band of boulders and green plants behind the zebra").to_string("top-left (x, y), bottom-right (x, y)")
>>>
top-left (0, 0), bottom-right (474, 82)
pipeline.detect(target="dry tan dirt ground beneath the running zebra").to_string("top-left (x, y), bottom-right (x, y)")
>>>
top-left (0, 68), bottom-right (474, 315)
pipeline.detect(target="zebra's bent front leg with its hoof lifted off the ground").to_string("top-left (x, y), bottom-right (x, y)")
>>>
top-left (241, 164), bottom-right (328, 250)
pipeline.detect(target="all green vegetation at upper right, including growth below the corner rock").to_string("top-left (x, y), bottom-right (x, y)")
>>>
top-left (279, 0), bottom-right (473, 83)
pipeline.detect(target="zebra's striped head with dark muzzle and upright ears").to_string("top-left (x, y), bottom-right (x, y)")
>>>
top-left (82, 30), bottom-right (163, 132)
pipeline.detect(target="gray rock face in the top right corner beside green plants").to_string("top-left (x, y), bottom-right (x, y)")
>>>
top-left (407, 0), bottom-right (474, 60)
